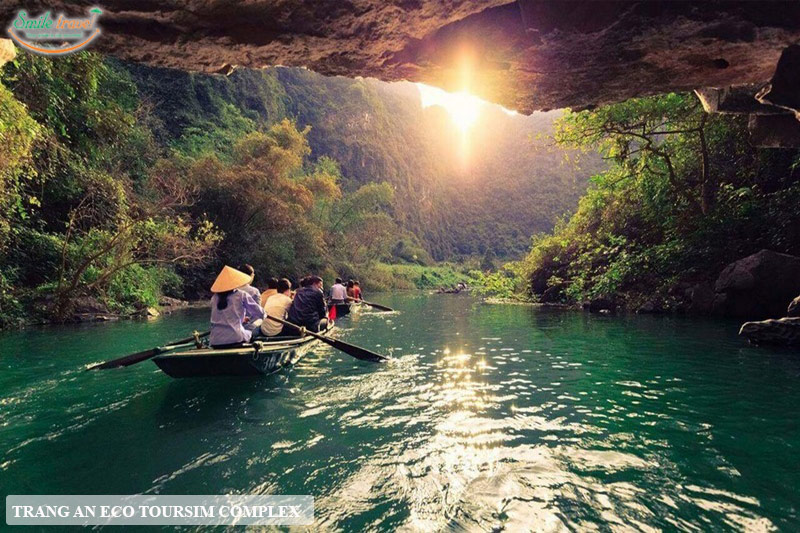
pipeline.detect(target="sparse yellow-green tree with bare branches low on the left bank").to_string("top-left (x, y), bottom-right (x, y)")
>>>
top-left (55, 164), bottom-right (221, 318)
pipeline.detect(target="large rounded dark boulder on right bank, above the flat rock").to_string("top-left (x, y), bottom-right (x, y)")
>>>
top-left (713, 250), bottom-right (800, 318)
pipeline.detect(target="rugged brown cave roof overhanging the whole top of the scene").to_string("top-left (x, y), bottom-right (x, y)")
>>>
top-left (0, 0), bottom-right (800, 113)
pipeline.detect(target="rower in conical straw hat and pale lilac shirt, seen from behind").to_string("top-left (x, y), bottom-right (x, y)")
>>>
top-left (209, 265), bottom-right (264, 348)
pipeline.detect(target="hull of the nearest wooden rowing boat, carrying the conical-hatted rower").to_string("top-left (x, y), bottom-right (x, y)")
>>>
top-left (153, 323), bottom-right (334, 378)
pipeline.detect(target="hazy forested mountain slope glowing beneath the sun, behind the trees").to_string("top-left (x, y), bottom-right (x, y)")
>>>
top-left (123, 64), bottom-right (602, 260)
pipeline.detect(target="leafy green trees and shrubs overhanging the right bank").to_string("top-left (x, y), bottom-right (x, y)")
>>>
top-left (523, 94), bottom-right (800, 308)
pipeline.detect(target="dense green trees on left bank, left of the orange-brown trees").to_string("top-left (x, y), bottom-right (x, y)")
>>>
top-left (0, 53), bottom-right (219, 322)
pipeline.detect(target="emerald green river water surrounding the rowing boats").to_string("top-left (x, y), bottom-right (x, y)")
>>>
top-left (0, 294), bottom-right (800, 531)
